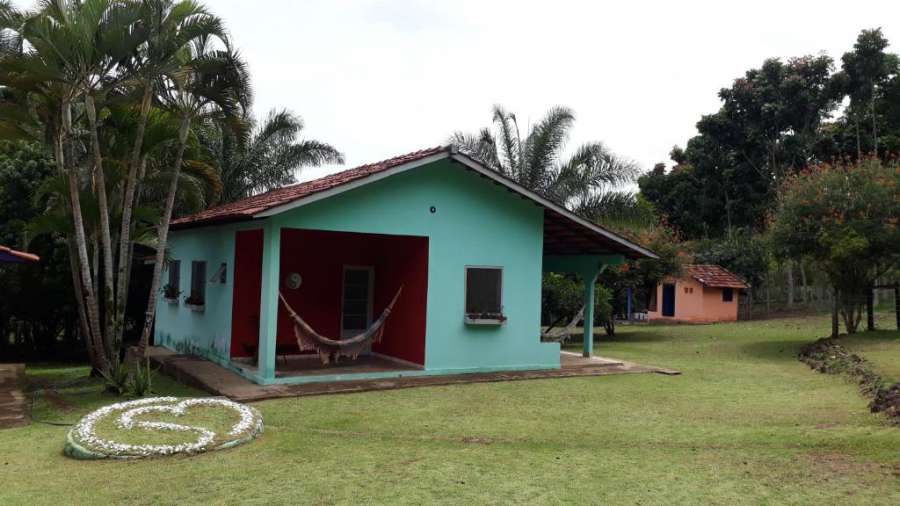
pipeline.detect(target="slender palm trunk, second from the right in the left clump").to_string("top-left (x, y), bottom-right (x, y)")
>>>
top-left (113, 87), bottom-right (152, 348)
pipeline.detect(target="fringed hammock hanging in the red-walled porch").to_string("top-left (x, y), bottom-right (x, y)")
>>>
top-left (278, 286), bottom-right (403, 365)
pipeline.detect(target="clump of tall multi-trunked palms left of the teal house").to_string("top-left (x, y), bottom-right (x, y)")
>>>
top-left (0, 0), bottom-right (239, 373)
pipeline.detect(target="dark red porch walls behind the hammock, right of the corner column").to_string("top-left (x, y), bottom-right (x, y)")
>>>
top-left (278, 229), bottom-right (428, 365)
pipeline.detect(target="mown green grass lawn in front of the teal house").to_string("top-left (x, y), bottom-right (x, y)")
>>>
top-left (0, 318), bottom-right (900, 504)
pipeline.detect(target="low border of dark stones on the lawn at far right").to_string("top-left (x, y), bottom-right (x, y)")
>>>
top-left (798, 337), bottom-right (900, 426)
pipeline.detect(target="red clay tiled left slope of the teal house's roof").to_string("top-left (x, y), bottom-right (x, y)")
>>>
top-left (172, 146), bottom-right (450, 228)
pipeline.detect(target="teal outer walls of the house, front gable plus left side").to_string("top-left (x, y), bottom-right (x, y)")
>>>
top-left (156, 160), bottom-right (559, 378)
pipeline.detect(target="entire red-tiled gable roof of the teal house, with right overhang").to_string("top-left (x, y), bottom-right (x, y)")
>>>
top-left (171, 145), bottom-right (657, 258)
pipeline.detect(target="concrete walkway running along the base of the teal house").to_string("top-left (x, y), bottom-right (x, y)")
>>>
top-left (149, 346), bottom-right (681, 402)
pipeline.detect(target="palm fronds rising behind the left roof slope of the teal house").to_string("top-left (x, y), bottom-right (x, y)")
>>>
top-left (198, 107), bottom-right (344, 202)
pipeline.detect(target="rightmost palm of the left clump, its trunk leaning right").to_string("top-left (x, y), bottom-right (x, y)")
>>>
top-left (139, 37), bottom-right (251, 353)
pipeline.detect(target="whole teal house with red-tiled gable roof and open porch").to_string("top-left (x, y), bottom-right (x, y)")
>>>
top-left (154, 146), bottom-right (653, 384)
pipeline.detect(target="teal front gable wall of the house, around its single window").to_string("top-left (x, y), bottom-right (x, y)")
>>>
top-left (273, 160), bottom-right (559, 371)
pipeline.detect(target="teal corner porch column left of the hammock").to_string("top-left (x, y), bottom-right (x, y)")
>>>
top-left (257, 218), bottom-right (281, 381)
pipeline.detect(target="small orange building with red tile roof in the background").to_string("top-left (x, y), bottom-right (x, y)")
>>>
top-left (647, 264), bottom-right (750, 323)
